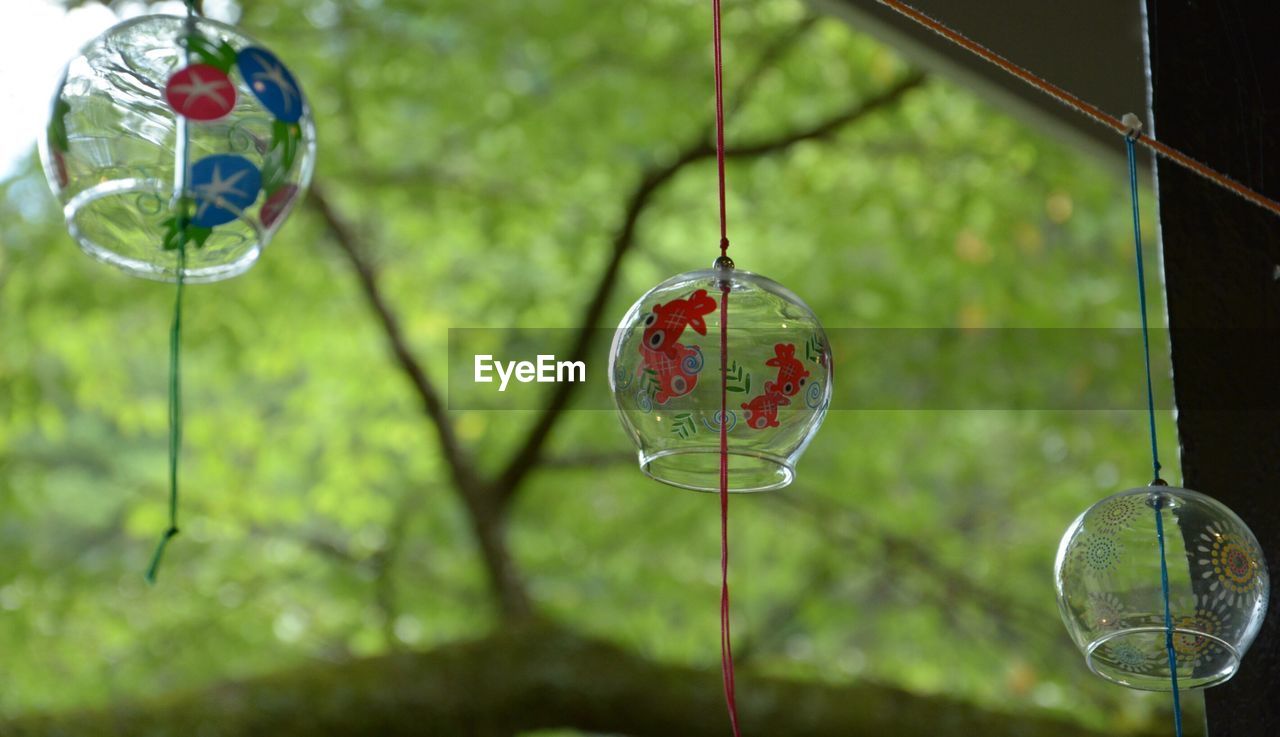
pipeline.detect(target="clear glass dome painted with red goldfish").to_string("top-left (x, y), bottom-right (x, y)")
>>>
top-left (609, 263), bottom-right (832, 491)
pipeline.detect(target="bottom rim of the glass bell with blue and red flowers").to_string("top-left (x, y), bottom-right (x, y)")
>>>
top-left (63, 178), bottom-right (268, 284)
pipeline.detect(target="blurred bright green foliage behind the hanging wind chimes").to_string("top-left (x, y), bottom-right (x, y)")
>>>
top-left (0, 0), bottom-right (1174, 731)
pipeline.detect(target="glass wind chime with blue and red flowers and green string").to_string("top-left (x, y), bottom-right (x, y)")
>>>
top-left (40, 0), bottom-right (315, 581)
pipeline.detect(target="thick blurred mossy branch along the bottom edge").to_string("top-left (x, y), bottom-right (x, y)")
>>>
top-left (0, 626), bottom-right (1164, 737)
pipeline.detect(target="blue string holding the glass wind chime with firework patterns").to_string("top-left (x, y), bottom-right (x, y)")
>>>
top-left (1124, 115), bottom-right (1183, 737)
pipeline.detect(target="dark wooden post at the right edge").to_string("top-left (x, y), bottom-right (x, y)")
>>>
top-left (1144, 0), bottom-right (1280, 737)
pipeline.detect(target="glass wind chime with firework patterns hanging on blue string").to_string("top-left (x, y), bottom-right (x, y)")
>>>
top-left (1055, 115), bottom-right (1270, 737)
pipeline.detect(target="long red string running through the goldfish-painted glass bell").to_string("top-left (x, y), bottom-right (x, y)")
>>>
top-left (712, 0), bottom-right (742, 737)
